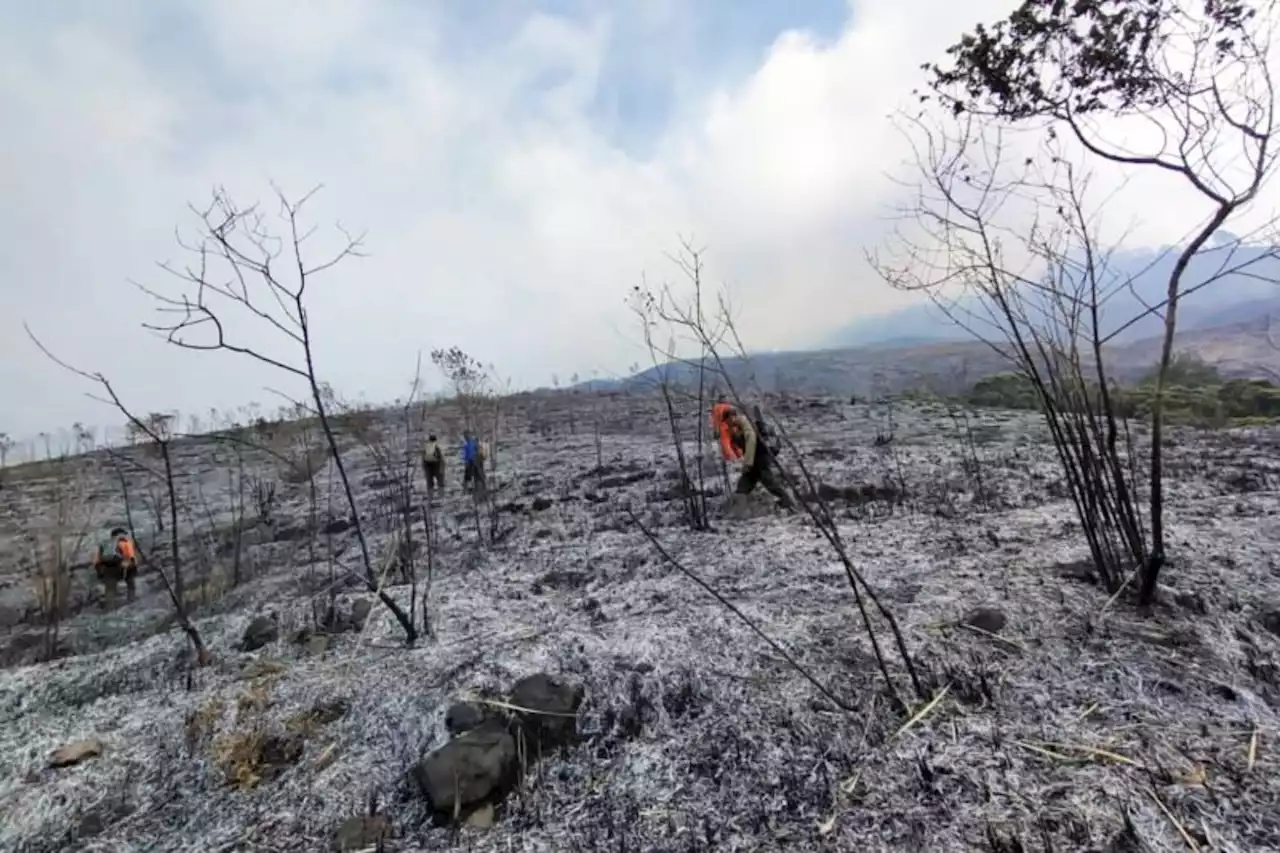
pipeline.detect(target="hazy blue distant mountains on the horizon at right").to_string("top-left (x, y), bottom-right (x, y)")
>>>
top-left (563, 234), bottom-right (1280, 396)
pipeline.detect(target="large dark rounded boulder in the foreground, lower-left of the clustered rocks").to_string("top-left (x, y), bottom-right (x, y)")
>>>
top-left (412, 720), bottom-right (520, 820)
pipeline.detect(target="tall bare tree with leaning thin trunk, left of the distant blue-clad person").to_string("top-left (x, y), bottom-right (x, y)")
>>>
top-left (137, 187), bottom-right (416, 643)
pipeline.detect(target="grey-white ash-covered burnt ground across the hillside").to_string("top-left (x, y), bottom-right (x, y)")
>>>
top-left (0, 397), bottom-right (1280, 853)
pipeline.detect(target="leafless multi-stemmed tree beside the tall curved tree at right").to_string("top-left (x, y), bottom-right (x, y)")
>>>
top-left (873, 118), bottom-right (1149, 590)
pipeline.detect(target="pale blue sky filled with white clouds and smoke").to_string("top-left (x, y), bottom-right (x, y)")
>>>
top-left (0, 0), bottom-right (1280, 448)
